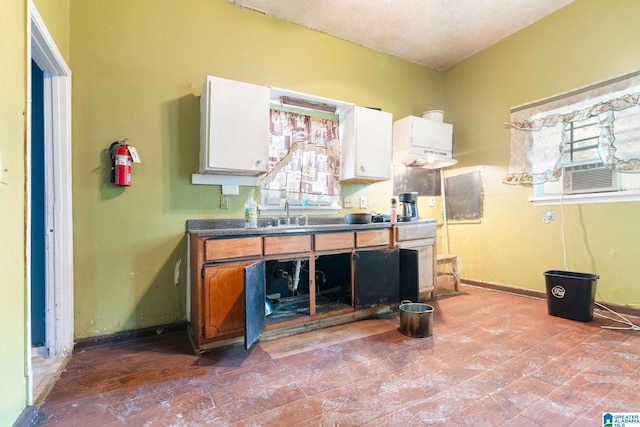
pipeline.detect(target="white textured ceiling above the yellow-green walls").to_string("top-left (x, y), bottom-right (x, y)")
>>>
top-left (227, 0), bottom-right (574, 70)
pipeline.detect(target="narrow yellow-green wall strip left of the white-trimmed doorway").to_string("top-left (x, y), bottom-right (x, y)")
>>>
top-left (0, 0), bottom-right (27, 423)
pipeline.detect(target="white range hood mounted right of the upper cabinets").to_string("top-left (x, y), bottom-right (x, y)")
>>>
top-left (393, 116), bottom-right (458, 169)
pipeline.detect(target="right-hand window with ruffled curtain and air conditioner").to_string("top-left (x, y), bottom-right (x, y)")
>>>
top-left (503, 73), bottom-right (640, 204)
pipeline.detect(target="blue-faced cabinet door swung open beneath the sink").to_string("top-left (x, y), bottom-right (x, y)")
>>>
top-left (244, 261), bottom-right (266, 349)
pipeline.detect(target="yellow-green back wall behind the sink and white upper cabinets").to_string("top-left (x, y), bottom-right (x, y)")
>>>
top-left (70, 0), bottom-right (441, 338)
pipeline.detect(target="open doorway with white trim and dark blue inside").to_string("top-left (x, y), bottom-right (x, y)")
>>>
top-left (26, 1), bottom-right (73, 404)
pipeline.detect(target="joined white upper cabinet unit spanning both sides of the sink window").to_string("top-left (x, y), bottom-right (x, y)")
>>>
top-left (192, 76), bottom-right (393, 186)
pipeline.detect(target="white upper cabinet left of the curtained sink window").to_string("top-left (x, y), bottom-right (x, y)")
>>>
top-left (200, 76), bottom-right (269, 175)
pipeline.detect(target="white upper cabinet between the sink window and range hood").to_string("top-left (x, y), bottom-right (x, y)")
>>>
top-left (341, 106), bottom-right (393, 182)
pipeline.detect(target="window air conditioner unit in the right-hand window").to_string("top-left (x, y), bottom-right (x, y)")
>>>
top-left (562, 163), bottom-right (618, 194)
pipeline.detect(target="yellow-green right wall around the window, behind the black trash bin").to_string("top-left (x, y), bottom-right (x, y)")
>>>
top-left (443, 0), bottom-right (640, 307)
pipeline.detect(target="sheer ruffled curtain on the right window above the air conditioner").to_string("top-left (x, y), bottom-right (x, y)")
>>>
top-left (502, 71), bottom-right (640, 185)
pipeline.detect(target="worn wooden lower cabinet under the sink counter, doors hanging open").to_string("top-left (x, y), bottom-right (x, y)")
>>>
top-left (190, 226), bottom-right (435, 352)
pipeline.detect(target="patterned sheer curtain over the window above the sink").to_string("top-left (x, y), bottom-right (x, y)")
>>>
top-left (262, 110), bottom-right (340, 206)
